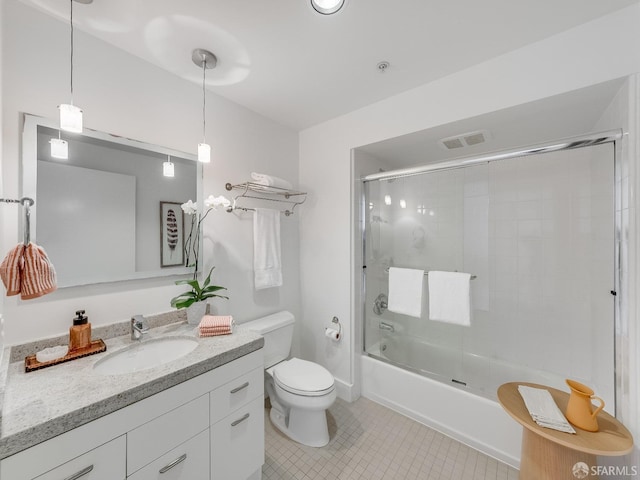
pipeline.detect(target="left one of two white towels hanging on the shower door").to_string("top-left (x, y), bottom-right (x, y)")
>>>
top-left (388, 267), bottom-right (424, 318)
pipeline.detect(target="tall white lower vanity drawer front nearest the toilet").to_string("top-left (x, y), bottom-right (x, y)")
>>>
top-left (211, 395), bottom-right (264, 480)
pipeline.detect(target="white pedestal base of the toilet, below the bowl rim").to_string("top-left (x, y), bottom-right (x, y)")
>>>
top-left (269, 406), bottom-right (329, 447)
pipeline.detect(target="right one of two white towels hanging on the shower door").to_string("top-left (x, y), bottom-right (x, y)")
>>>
top-left (429, 271), bottom-right (471, 326)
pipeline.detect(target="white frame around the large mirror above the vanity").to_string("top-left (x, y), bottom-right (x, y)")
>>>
top-left (19, 113), bottom-right (203, 288)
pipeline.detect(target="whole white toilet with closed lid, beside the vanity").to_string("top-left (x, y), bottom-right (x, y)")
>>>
top-left (243, 311), bottom-right (336, 447)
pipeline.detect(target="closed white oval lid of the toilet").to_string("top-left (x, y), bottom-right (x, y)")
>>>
top-left (273, 358), bottom-right (334, 396)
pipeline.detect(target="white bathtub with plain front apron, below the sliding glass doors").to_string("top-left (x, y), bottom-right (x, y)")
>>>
top-left (361, 335), bottom-right (552, 468)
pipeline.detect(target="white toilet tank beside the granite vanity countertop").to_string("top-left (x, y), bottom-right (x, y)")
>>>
top-left (242, 311), bottom-right (295, 368)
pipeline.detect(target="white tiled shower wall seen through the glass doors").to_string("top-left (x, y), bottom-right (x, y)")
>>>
top-left (365, 144), bottom-right (615, 406)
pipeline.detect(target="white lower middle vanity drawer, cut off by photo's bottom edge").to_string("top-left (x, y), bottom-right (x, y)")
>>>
top-left (128, 428), bottom-right (210, 480)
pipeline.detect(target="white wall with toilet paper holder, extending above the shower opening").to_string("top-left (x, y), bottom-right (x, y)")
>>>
top-left (300, 0), bottom-right (640, 442)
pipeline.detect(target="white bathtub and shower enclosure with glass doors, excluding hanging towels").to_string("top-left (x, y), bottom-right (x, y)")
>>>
top-left (356, 132), bottom-right (620, 466)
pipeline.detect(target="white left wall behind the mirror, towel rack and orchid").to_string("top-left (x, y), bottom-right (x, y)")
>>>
top-left (0, 0), bottom-right (299, 344)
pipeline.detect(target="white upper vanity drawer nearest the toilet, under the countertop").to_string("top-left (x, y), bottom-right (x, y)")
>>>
top-left (210, 367), bottom-right (264, 425)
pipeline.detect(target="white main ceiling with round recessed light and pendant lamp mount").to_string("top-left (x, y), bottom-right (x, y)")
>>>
top-left (22, 0), bottom-right (639, 130)
